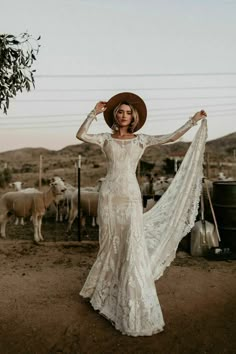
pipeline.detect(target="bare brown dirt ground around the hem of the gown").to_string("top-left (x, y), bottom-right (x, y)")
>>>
top-left (0, 224), bottom-right (236, 354)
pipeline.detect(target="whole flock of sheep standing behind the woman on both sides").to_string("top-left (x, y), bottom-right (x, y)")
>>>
top-left (0, 176), bottom-right (173, 243)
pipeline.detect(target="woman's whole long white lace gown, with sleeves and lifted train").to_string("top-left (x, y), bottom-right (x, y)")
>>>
top-left (77, 111), bottom-right (207, 336)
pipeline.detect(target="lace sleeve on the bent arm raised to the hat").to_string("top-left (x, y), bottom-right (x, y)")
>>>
top-left (76, 109), bottom-right (104, 147)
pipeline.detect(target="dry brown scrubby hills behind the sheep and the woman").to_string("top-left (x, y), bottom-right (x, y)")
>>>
top-left (0, 132), bottom-right (236, 185)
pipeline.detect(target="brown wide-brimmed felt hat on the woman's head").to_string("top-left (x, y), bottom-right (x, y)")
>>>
top-left (103, 92), bottom-right (147, 131)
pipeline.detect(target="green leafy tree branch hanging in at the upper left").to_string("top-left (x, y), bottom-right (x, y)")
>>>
top-left (0, 33), bottom-right (41, 114)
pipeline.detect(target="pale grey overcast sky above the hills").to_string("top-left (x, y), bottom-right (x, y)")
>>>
top-left (0, 0), bottom-right (236, 151)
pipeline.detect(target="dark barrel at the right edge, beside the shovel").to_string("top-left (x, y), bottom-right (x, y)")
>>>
top-left (213, 181), bottom-right (236, 250)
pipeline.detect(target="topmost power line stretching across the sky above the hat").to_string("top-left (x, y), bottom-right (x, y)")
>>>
top-left (35, 72), bottom-right (236, 79)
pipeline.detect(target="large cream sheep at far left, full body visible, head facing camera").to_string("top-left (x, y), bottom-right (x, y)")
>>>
top-left (0, 177), bottom-right (66, 243)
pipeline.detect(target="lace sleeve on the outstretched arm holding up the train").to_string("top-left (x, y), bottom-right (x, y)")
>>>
top-left (143, 118), bottom-right (196, 147)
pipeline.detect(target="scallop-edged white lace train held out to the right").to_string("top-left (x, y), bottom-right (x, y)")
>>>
top-left (144, 119), bottom-right (207, 280)
